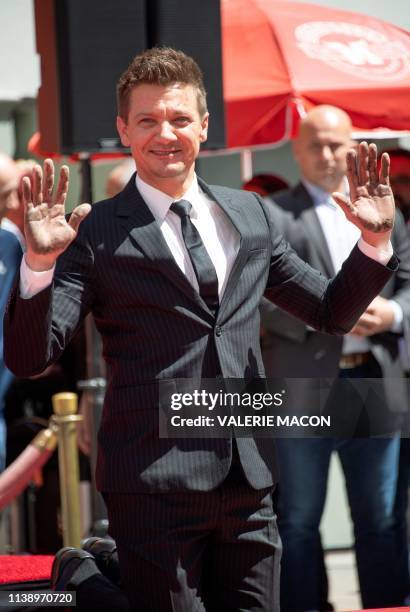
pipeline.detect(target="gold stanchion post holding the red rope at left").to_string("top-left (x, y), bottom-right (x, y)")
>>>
top-left (52, 392), bottom-right (82, 547)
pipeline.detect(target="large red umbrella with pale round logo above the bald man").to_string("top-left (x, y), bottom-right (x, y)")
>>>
top-left (221, 0), bottom-right (410, 147)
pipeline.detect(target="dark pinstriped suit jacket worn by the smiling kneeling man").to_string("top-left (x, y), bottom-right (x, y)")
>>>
top-left (5, 176), bottom-right (397, 492)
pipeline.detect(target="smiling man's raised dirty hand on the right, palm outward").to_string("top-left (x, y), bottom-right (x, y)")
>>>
top-left (332, 142), bottom-right (395, 250)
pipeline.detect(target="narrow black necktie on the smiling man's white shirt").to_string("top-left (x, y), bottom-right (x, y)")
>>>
top-left (170, 200), bottom-right (219, 314)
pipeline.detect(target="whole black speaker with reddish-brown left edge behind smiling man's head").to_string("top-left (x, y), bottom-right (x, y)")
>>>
top-left (35, 0), bottom-right (225, 154)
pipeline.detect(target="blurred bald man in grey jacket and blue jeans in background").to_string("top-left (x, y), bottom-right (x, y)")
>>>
top-left (261, 106), bottom-right (410, 612)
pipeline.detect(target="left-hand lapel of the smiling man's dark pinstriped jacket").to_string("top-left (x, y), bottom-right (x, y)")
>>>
top-left (117, 174), bottom-right (211, 314)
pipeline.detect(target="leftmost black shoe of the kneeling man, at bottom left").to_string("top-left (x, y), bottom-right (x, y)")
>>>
top-left (51, 546), bottom-right (100, 591)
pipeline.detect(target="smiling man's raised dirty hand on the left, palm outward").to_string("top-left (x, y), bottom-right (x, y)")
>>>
top-left (22, 159), bottom-right (91, 272)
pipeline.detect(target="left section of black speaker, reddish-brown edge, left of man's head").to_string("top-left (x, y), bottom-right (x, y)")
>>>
top-left (35, 0), bottom-right (147, 154)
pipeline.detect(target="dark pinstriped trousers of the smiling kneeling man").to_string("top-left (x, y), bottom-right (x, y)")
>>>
top-left (104, 443), bottom-right (281, 612)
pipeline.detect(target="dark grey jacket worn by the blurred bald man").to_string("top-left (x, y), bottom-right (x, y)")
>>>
top-left (261, 183), bottom-right (410, 412)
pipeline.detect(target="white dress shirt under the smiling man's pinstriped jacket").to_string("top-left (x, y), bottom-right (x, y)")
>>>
top-left (20, 174), bottom-right (240, 299)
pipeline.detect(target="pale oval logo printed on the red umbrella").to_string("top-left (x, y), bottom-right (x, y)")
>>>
top-left (295, 21), bottom-right (410, 81)
